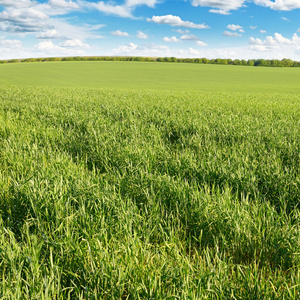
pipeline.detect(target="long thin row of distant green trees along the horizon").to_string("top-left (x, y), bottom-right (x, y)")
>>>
top-left (0, 56), bottom-right (300, 67)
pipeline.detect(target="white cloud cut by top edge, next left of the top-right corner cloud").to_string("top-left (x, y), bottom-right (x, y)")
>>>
top-left (192, 0), bottom-right (246, 15)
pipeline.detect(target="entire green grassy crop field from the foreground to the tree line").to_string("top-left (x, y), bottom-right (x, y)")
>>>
top-left (0, 62), bottom-right (300, 300)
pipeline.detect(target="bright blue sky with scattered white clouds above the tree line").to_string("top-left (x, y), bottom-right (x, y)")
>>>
top-left (0, 0), bottom-right (300, 60)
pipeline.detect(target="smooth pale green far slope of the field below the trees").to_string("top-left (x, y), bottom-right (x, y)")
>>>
top-left (0, 62), bottom-right (300, 93)
